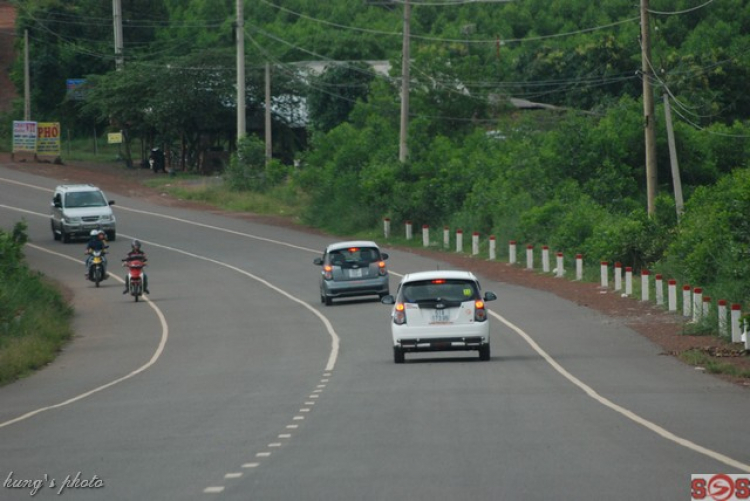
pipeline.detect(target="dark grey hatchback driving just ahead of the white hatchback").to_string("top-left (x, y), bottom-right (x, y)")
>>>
top-left (313, 240), bottom-right (390, 306)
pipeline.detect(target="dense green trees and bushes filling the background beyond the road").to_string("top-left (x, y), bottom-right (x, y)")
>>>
top-left (8, 0), bottom-right (750, 301)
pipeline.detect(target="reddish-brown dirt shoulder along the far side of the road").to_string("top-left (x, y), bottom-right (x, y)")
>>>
top-left (0, 153), bottom-right (750, 388)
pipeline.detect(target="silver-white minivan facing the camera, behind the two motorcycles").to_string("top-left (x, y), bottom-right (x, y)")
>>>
top-left (50, 184), bottom-right (117, 243)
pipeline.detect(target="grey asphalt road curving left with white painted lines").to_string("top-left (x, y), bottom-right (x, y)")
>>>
top-left (0, 163), bottom-right (750, 501)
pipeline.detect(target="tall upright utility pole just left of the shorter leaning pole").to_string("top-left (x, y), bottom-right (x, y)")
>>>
top-left (641, 0), bottom-right (657, 216)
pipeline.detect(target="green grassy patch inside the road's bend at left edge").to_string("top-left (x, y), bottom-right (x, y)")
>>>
top-left (0, 266), bottom-right (73, 386)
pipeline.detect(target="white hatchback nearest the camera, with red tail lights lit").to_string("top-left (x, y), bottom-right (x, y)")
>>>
top-left (381, 270), bottom-right (497, 364)
